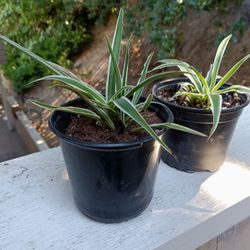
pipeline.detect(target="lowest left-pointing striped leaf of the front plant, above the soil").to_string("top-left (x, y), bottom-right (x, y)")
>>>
top-left (29, 100), bottom-right (102, 122)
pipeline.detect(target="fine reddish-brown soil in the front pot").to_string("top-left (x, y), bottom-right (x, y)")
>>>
top-left (65, 111), bottom-right (162, 143)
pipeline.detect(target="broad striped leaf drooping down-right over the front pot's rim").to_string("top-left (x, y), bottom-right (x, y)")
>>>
top-left (114, 97), bottom-right (172, 154)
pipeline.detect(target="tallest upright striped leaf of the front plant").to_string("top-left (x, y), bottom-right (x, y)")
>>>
top-left (106, 8), bottom-right (124, 101)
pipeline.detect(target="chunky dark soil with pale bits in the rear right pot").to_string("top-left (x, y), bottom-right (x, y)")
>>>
top-left (157, 88), bottom-right (243, 109)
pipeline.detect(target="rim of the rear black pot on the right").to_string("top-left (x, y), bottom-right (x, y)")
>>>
top-left (152, 77), bottom-right (250, 114)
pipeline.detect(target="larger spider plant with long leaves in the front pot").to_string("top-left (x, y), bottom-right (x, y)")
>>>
top-left (0, 9), bottom-right (205, 153)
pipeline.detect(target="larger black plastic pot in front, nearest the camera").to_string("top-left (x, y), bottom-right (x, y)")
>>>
top-left (49, 100), bottom-right (173, 223)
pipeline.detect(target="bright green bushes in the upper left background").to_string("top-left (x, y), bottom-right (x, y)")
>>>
top-left (0, 0), bottom-right (119, 93)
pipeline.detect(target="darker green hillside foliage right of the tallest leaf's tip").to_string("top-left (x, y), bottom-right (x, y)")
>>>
top-left (127, 0), bottom-right (245, 58)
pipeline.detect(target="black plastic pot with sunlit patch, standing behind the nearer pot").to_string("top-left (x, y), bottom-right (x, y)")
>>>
top-left (153, 78), bottom-right (249, 172)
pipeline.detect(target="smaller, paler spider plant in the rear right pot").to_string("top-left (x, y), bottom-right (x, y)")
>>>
top-left (153, 35), bottom-right (250, 139)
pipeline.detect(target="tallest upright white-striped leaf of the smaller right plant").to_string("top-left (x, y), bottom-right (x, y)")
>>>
top-left (208, 35), bottom-right (232, 89)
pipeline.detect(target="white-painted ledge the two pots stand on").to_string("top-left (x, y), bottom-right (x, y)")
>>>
top-left (0, 104), bottom-right (250, 250)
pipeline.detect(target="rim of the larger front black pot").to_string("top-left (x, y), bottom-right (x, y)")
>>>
top-left (48, 98), bottom-right (174, 150)
